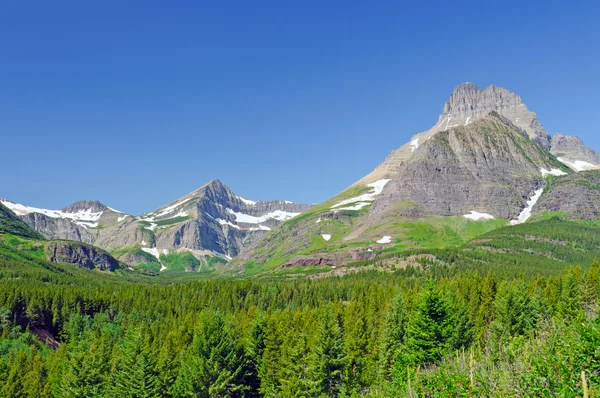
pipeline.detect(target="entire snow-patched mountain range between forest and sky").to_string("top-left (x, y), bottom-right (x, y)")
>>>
top-left (0, 83), bottom-right (600, 275)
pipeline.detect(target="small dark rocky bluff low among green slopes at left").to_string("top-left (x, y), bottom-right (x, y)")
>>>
top-left (46, 241), bottom-right (119, 271)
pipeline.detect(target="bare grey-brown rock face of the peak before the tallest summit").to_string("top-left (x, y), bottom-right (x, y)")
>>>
top-left (370, 112), bottom-right (566, 222)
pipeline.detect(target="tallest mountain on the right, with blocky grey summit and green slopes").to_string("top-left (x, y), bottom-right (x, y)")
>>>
top-left (232, 83), bottom-right (600, 269)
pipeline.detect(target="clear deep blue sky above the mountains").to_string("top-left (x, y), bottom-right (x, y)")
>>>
top-left (0, 0), bottom-right (600, 214)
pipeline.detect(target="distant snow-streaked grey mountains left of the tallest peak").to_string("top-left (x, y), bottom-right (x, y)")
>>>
top-left (2, 180), bottom-right (311, 265)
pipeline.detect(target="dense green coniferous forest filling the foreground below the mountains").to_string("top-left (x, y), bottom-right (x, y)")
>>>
top-left (0, 236), bottom-right (600, 397)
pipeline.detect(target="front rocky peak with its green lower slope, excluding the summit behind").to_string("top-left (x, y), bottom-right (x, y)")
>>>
top-left (232, 113), bottom-right (571, 274)
